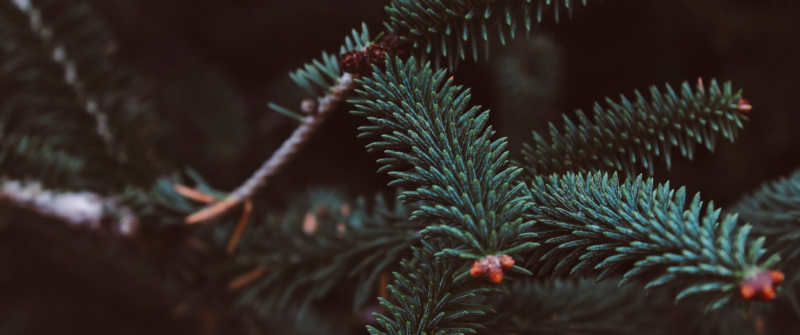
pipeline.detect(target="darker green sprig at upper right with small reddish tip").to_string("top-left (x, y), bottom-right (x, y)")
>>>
top-left (522, 80), bottom-right (747, 178)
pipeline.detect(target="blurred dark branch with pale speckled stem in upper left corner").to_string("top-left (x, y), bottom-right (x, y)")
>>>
top-left (12, 0), bottom-right (163, 181)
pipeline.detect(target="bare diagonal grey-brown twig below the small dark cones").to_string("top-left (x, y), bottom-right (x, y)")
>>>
top-left (186, 73), bottom-right (355, 224)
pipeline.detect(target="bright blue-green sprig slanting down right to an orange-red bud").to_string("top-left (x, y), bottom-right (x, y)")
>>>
top-left (525, 173), bottom-right (780, 310)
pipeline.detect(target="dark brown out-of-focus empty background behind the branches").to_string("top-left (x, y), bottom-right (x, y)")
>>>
top-left (0, 0), bottom-right (800, 334)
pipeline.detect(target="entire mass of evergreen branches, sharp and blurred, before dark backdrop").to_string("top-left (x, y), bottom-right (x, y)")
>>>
top-left (0, 0), bottom-right (800, 335)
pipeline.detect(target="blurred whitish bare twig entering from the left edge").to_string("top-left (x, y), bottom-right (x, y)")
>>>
top-left (0, 180), bottom-right (139, 236)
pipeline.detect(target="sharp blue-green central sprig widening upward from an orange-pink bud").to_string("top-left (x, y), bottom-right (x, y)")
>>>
top-left (352, 57), bottom-right (536, 262)
